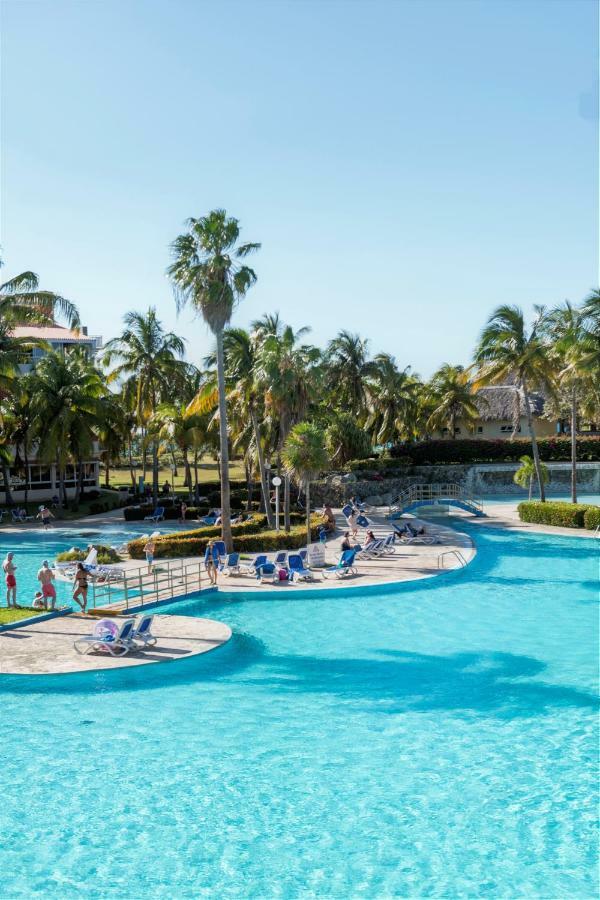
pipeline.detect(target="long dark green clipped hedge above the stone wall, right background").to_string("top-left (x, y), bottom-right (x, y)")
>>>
top-left (390, 437), bottom-right (600, 466)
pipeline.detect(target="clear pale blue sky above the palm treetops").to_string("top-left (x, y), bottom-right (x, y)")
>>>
top-left (1, 0), bottom-right (598, 376)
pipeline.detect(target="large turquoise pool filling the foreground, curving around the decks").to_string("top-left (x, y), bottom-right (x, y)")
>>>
top-left (0, 521), bottom-right (600, 898)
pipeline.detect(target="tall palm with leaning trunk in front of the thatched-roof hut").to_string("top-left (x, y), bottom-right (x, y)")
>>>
top-left (474, 306), bottom-right (553, 502)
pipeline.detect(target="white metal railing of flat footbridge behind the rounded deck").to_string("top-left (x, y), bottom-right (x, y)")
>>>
top-left (89, 559), bottom-right (203, 610)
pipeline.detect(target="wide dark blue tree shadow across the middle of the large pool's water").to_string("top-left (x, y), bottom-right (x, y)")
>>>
top-left (254, 650), bottom-right (599, 718)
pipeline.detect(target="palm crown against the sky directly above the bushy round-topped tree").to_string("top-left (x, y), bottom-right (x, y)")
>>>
top-left (325, 331), bottom-right (375, 416)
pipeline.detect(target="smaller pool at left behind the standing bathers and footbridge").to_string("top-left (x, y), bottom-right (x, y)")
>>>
top-left (0, 522), bottom-right (198, 607)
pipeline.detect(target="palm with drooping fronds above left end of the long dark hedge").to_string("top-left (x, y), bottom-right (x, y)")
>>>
top-left (365, 353), bottom-right (421, 444)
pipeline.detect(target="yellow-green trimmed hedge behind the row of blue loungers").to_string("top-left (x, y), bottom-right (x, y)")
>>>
top-left (128, 513), bottom-right (323, 559)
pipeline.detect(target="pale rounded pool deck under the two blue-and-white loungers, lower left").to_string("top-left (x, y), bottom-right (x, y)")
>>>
top-left (0, 614), bottom-right (231, 675)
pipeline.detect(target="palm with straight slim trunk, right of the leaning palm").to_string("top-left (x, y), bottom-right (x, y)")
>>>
top-left (545, 300), bottom-right (591, 503)
